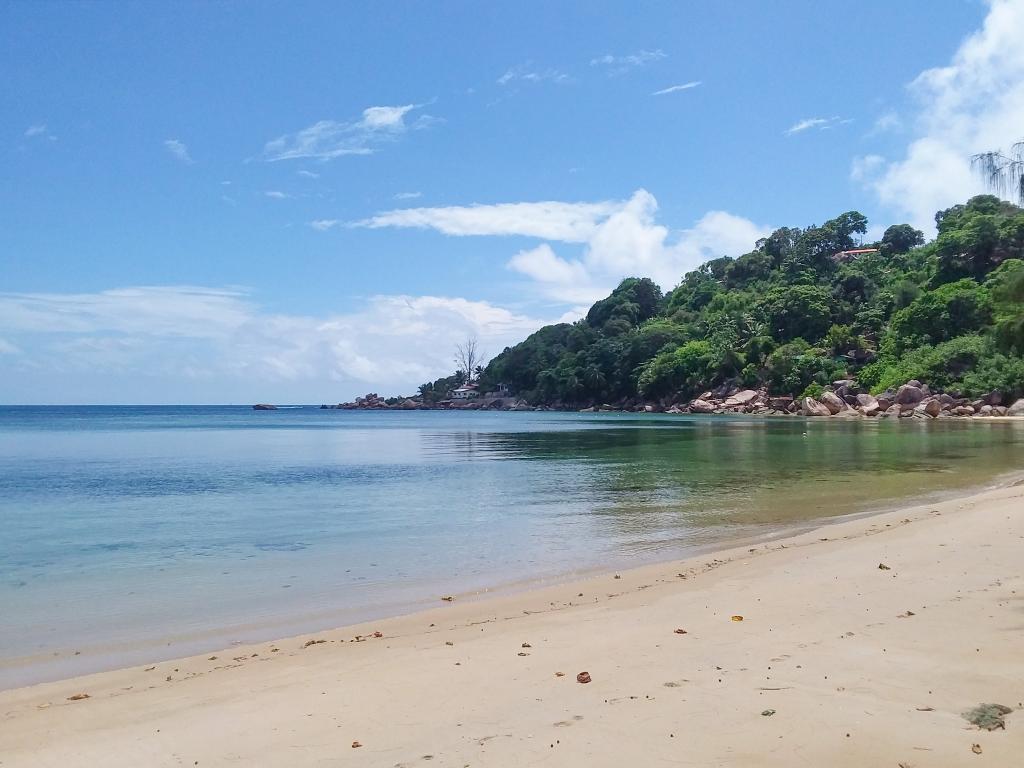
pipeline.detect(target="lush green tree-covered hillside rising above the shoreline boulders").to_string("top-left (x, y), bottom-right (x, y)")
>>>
top-left (481, 196), bottom-right (1024, 407)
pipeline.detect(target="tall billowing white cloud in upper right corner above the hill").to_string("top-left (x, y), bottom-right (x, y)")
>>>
top-left (870, 0), bottom-right (1024, 232)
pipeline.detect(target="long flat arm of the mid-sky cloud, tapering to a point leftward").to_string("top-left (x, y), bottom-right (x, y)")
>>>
top-left (352, 201), bottom-right (621, 243)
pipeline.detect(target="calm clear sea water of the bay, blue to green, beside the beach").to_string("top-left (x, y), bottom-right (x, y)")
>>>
top-left (0, 407), bottom-right (1024, 687)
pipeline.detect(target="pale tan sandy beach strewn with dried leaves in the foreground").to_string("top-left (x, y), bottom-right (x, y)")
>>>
top-left (0, 483), bottom-right (1024, 768)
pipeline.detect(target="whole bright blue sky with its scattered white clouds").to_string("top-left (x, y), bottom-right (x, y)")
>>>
top-left (0, 0), bottom-right (1024, 403)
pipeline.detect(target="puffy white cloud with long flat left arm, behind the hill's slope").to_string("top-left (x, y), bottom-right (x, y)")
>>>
top-left (354, 189), bottom-right (769, 304)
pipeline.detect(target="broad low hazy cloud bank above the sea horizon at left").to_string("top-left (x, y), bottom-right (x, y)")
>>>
top-left (0, 286), bottom-right (551, 401)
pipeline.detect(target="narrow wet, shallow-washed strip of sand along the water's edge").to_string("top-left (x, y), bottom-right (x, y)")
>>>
top-left (6, 471), bottom-right (1024, 694)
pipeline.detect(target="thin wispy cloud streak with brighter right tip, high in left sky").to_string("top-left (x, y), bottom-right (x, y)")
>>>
top-left (262, 104), bottom-right (437, 162)
